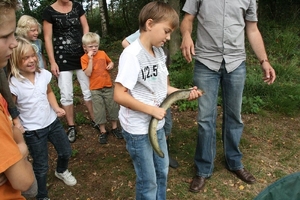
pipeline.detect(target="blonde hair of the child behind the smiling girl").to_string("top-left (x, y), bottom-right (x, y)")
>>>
top-left (16, 15), bottom-right (42, 38)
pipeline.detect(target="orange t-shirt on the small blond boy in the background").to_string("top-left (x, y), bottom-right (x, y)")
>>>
top-left (81, 51), bottom-right (112, 90)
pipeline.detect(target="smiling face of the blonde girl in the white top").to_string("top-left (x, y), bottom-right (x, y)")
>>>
top-left (19, 46), bottom-right (38, 75)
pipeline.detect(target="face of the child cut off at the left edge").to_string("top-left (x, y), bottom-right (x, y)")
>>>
top-left (0, 9), bottom-right (18, 67)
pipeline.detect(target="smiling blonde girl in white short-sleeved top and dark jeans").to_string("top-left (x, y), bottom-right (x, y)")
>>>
top-left (8, 37), bottom-right (77, 199)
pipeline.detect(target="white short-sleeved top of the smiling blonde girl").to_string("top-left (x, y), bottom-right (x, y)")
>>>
top-left (9, 69), bottom-right (57, 131)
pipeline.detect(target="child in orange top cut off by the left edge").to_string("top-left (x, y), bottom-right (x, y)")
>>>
top-left (0, 0), bottom-right (34, 200)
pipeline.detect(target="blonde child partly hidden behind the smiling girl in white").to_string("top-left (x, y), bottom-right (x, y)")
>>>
top-left (16, 15), bottom-right (47, 69)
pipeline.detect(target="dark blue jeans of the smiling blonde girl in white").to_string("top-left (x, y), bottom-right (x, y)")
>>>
top-left (24, 118), bottom-right (72, 199)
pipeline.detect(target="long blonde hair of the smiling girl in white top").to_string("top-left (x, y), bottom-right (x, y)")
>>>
top-left (7, 37), bottom-right (40, 80)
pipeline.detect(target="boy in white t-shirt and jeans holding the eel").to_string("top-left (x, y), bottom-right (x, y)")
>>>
top-left (114, 1), bottom-right (202, 200)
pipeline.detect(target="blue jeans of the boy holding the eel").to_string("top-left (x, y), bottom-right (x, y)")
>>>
top-left (123, 128), bottom-right (169, 200)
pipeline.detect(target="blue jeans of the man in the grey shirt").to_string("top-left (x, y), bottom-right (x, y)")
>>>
top-left (194, 61), bottom-right (246, 177)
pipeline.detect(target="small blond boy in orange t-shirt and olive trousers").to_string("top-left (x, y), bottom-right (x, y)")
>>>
top-left (81, 32), bottom-right (123, 144)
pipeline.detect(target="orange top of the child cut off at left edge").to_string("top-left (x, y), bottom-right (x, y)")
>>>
top-left (0, 94), bottom-right (25, 200)
